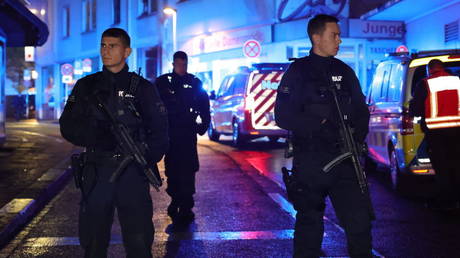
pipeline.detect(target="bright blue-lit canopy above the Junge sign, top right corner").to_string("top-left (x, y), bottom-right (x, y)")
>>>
top-left (361, 0), bottom-right (460, 23)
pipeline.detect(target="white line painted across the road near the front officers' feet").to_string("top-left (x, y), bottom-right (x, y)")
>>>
top-left (24, 229), bottom-right (294, 247)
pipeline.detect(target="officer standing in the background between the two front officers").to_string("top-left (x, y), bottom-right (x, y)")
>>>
top-left (155, 51), bottom-right (210, 224)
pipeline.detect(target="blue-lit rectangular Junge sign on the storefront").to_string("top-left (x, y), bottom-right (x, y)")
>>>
top-left (349, 19), bottom-right (405, 39)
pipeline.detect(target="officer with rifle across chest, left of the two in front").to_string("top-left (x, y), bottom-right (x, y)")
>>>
top-left (59, 28), bottom-right (168, 257)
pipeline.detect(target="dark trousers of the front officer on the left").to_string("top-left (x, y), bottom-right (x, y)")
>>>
top-left (79, 157), bottom-right (154, 258)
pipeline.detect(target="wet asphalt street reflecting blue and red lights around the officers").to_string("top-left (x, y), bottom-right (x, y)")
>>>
top-left (0, 122), bottom-right (460, 257)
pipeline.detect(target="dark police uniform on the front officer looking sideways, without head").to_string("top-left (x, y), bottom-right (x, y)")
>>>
top-left (275, 51), bottom-right (372, 257)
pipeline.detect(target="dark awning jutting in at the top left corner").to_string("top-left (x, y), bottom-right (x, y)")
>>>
top-left (0, 0), bottom-right (49, 47)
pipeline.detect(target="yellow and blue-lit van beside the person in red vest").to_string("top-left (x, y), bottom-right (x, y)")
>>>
top-left (366, 50), bottom-right (460, 190)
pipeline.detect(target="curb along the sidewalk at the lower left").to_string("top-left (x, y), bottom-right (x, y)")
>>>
top-left (0, 159), bottom-right (72, 249)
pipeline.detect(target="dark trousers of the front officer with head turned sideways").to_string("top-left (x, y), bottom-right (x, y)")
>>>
top-left (294, 152), bottom-right (372, 257)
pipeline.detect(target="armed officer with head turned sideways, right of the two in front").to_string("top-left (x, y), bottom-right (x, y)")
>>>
top-left (275, 14), bottom-right (374, 257)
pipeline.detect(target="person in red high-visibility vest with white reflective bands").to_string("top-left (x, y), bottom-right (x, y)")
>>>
top-left (409, 59), bottom-right (460, 209)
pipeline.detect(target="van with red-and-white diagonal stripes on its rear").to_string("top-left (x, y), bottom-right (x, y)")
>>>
top-left (208, 63), bottom-right (289, 146)
